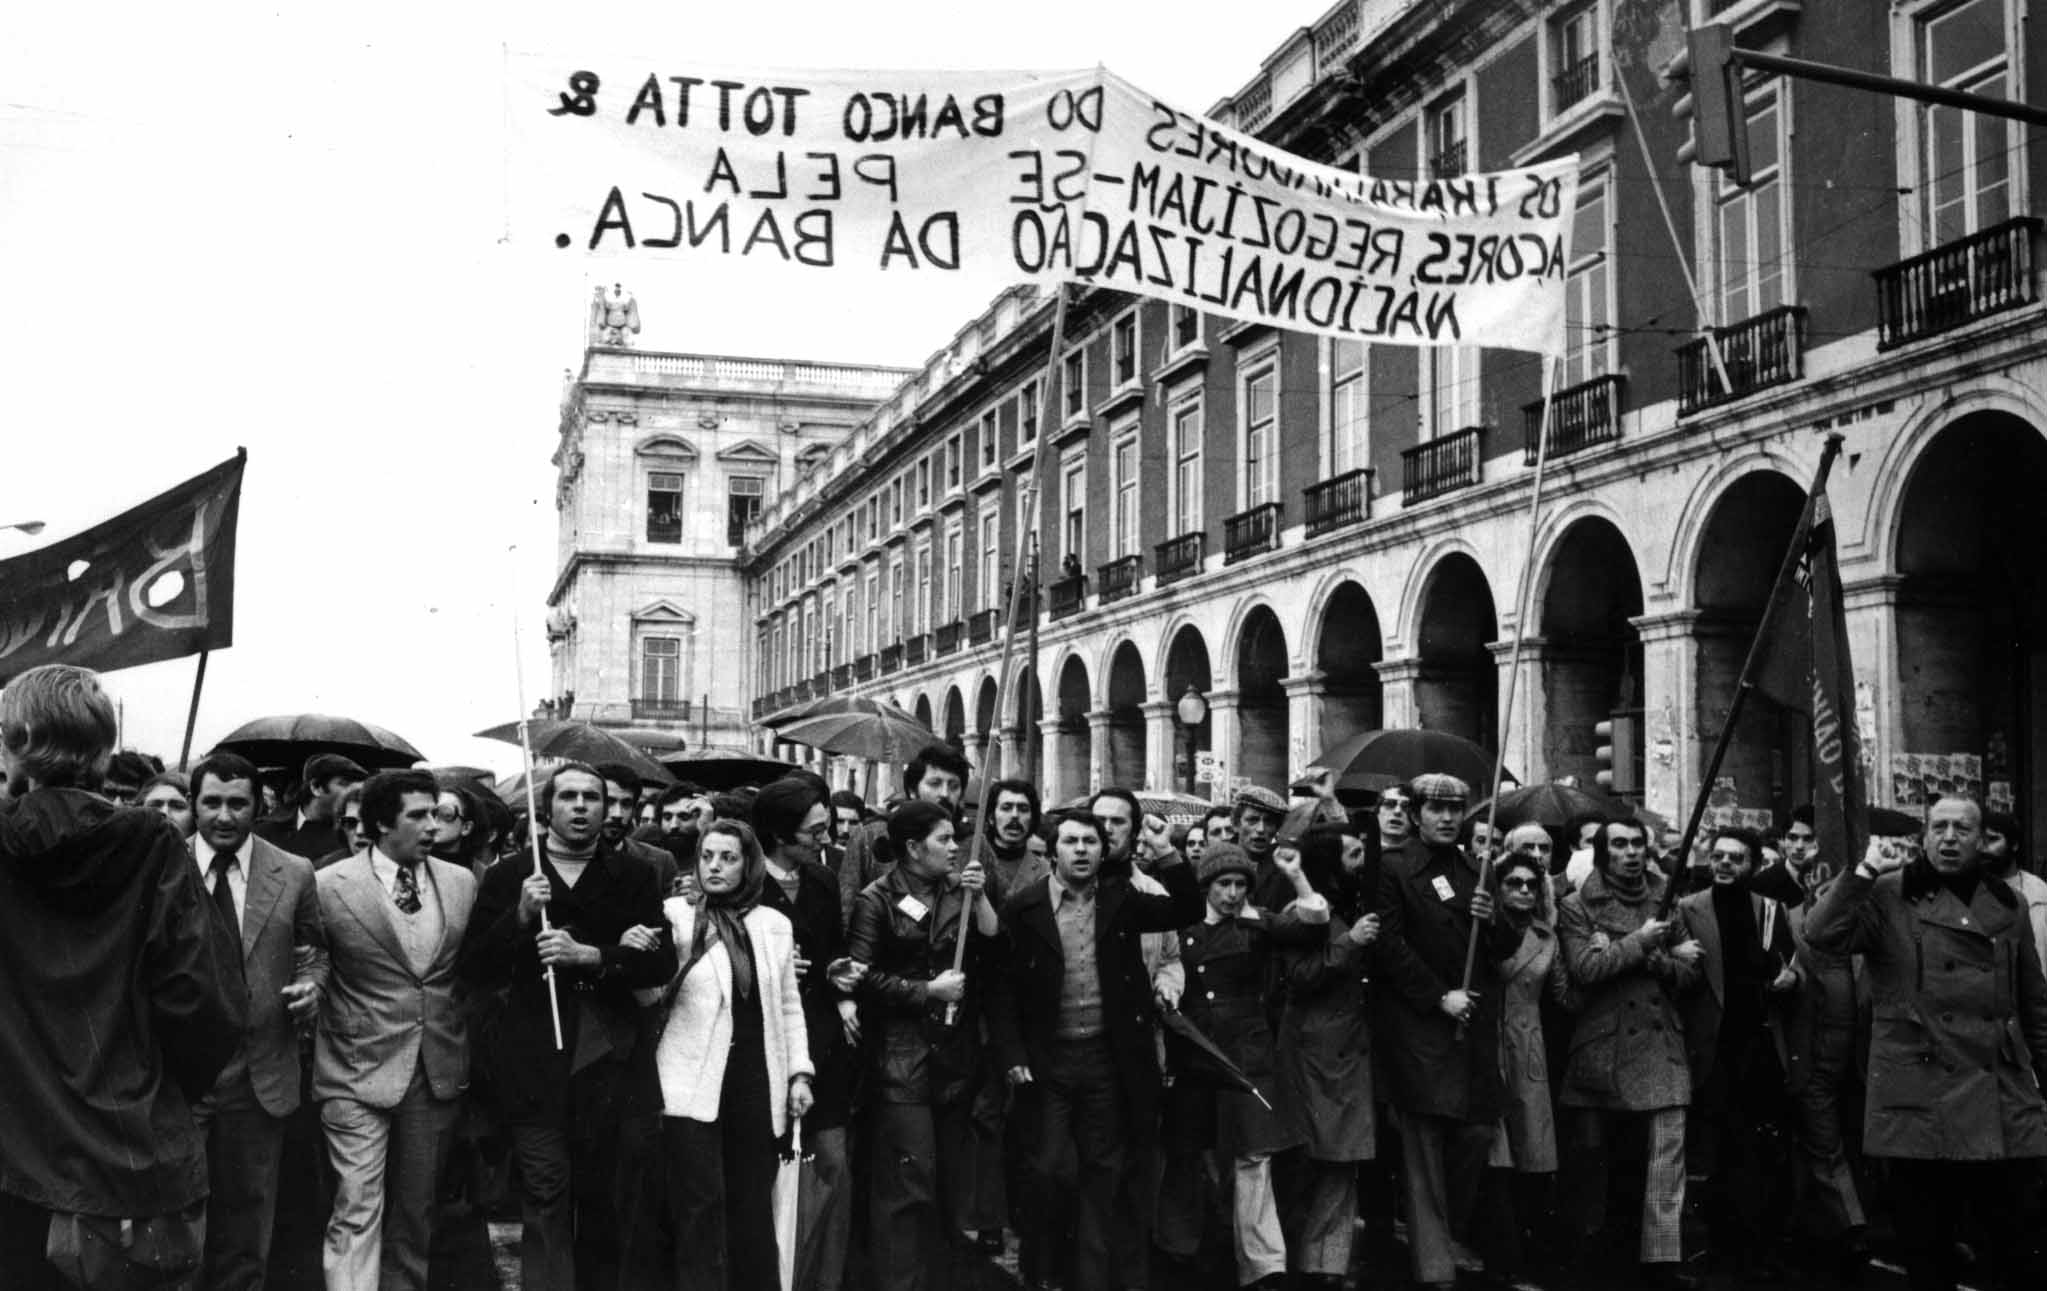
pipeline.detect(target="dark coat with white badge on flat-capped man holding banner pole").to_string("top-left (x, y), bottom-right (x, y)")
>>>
top-left (1378, 845), bottom-right (1521, 1125)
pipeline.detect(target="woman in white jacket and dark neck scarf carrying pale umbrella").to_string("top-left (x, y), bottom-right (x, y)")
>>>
top-left (655, 820), bottom-right (813, 1291)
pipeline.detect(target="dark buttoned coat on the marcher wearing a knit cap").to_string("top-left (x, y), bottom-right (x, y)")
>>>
top-left (1179, 898), bottom-right (1329, 1158)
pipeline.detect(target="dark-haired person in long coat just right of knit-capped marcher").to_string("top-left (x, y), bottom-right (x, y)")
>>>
top-left (1277, 825), bottom-right (1380, 1287)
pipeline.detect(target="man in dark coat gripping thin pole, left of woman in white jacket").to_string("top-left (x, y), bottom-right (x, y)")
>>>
top-left (461, 763), bottom-right (676, 1291)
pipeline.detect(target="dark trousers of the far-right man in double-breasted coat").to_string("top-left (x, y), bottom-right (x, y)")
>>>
top-left (1885, 1160), bottom-right (2043, 1291)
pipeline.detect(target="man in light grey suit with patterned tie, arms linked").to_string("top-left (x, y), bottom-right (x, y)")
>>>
top-left (313, 771), bottom-right (477, 1291)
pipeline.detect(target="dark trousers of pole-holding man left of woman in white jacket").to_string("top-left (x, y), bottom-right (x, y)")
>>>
top-left (512, 1062), bottom-right (624, 1291)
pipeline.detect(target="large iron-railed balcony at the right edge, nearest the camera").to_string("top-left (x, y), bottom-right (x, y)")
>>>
top-left (1871, 215), bottom-right (2041, 350)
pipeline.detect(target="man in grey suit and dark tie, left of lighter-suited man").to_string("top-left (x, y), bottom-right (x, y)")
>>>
top-left (190, 753), bottom-right (328, 1291)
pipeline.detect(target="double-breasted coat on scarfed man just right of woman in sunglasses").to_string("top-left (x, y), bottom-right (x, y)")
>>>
top-left (1558, 870), bottom-right (1699, 1111)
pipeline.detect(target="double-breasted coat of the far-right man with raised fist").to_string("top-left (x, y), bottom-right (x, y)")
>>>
top-left (1805, 859), bottom-right (2047, 1160)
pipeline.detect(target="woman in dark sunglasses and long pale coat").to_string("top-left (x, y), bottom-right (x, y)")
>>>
top-left (1488, 847), bottom-right (1574, 1273)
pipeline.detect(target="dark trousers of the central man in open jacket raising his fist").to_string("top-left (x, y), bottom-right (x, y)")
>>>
top-left (1032, 1037), bottom-right (1136, 1291)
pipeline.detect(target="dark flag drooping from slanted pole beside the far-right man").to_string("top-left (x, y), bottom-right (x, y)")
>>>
top-left (1752, 475), bottom-right (1869, 872)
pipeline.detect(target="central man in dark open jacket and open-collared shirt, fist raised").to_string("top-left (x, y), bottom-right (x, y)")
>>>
top-left (991, 814), bottom-right (1202, 1291)
